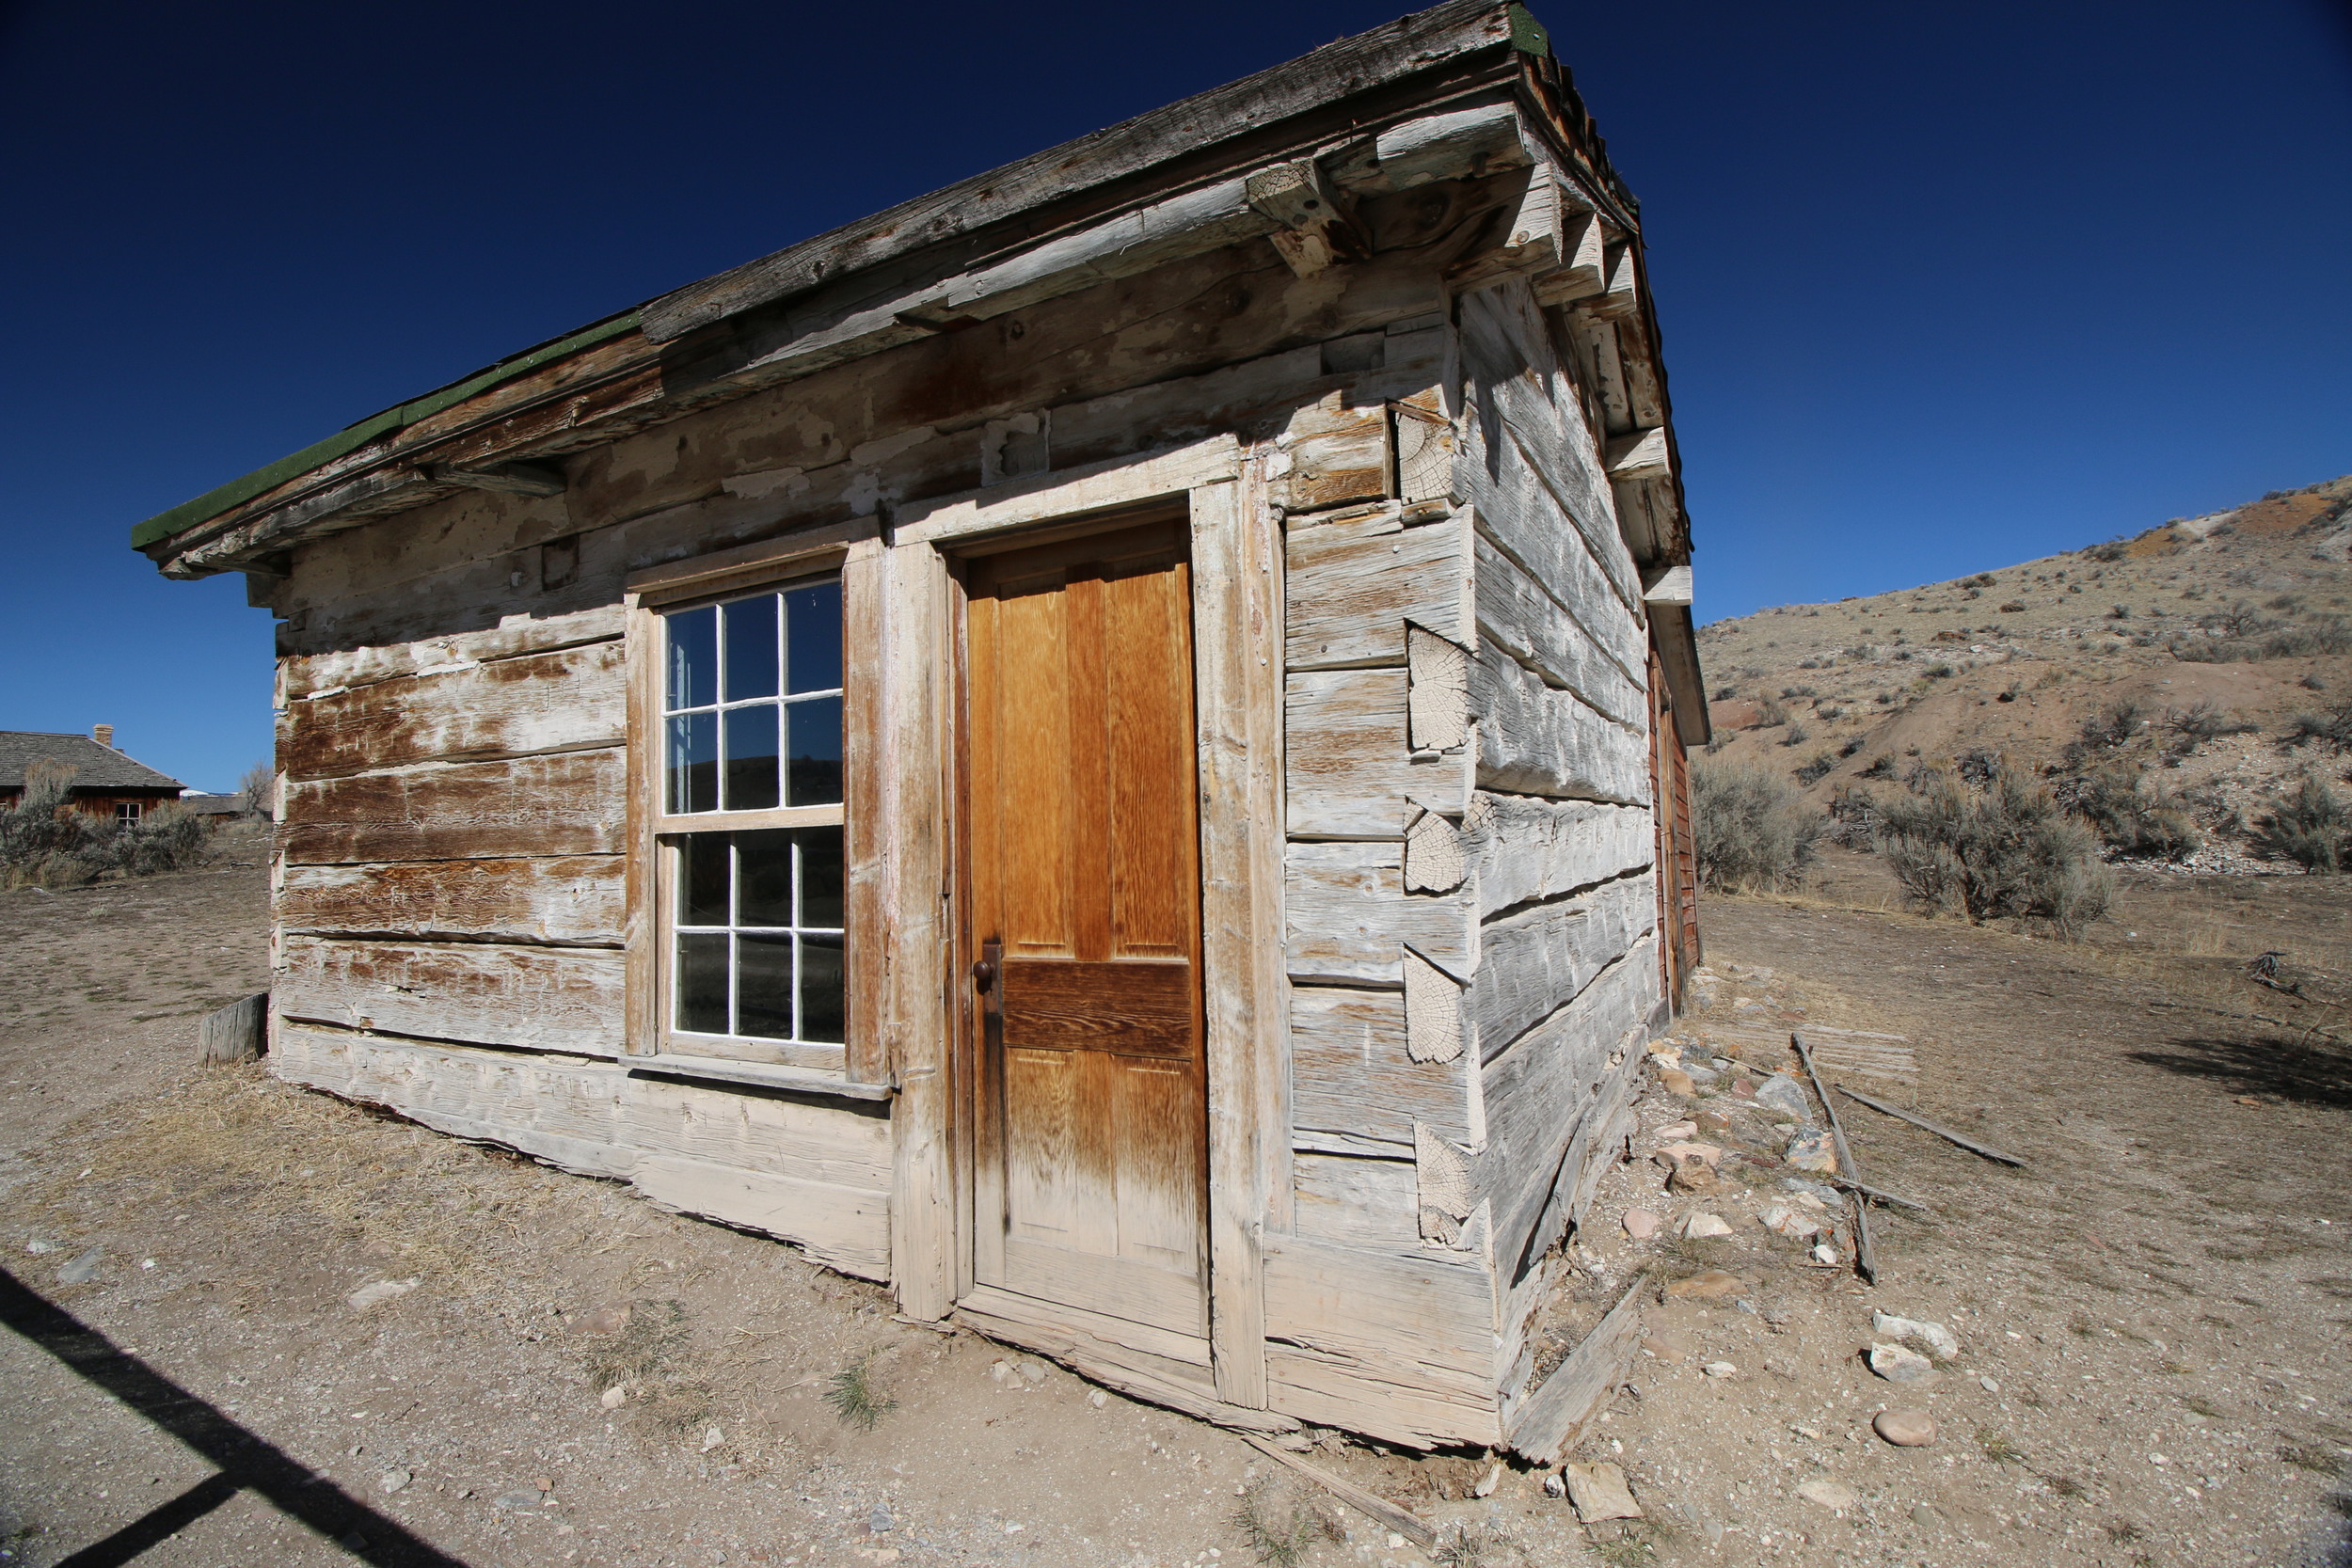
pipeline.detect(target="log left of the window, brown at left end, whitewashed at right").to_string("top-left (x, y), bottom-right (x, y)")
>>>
top-left (278, 641), bottom-right (626, 778)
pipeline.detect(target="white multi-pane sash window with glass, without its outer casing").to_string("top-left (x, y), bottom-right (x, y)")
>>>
top-left (657, 578), bottom-right (850, 1068)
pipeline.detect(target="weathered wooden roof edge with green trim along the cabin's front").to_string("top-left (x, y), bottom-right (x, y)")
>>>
top-left (132, 0), bottom-right (1635, 576)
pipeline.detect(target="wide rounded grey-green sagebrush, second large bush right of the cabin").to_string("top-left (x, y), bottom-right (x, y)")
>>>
top-left (1877, 768), bottom-right (2115, 936)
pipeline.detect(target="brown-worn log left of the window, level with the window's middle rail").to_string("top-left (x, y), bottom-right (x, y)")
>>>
top-left (278, 745), bottom-right (628, 865)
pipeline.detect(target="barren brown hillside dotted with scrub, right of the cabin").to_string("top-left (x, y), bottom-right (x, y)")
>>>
top-left (1701, 475), bottom-right (2352, 870)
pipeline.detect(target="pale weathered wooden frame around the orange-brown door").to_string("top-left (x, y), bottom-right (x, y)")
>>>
top-left (875, 435), bottom-right (1292, 1411)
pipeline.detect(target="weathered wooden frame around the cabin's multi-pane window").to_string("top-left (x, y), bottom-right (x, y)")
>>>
top-left (624, 519), bottom-right (889, 1098)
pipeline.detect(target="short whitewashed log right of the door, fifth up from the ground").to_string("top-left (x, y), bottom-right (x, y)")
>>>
top-left (1284, 670), bottom-right (1470, 839)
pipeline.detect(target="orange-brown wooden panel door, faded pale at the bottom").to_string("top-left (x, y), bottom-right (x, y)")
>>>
top-left (964, 522), bottom-right (1209, 1336)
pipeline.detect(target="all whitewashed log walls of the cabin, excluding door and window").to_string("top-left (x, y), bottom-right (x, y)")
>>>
top-left (257, 137), bottom-right (1661, 1444)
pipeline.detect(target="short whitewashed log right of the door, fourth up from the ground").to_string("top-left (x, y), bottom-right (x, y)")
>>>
top-left (1282, 842), bottom-right (1477, 985)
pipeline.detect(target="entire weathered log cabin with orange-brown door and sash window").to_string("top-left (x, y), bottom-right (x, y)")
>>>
top-left (135, 0), bottom-right (1708, 1453)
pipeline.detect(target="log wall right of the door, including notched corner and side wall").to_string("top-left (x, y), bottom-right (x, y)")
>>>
top-left (1268, 255), bottom-right (1661, 1441)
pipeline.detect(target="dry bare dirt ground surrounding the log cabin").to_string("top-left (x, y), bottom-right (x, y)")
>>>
top-left (0, 861), bottom-right (2352, 1568)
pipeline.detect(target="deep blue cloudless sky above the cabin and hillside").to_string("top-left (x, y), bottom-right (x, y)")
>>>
top-left (0, 0), bottom-right (2352, 790)
